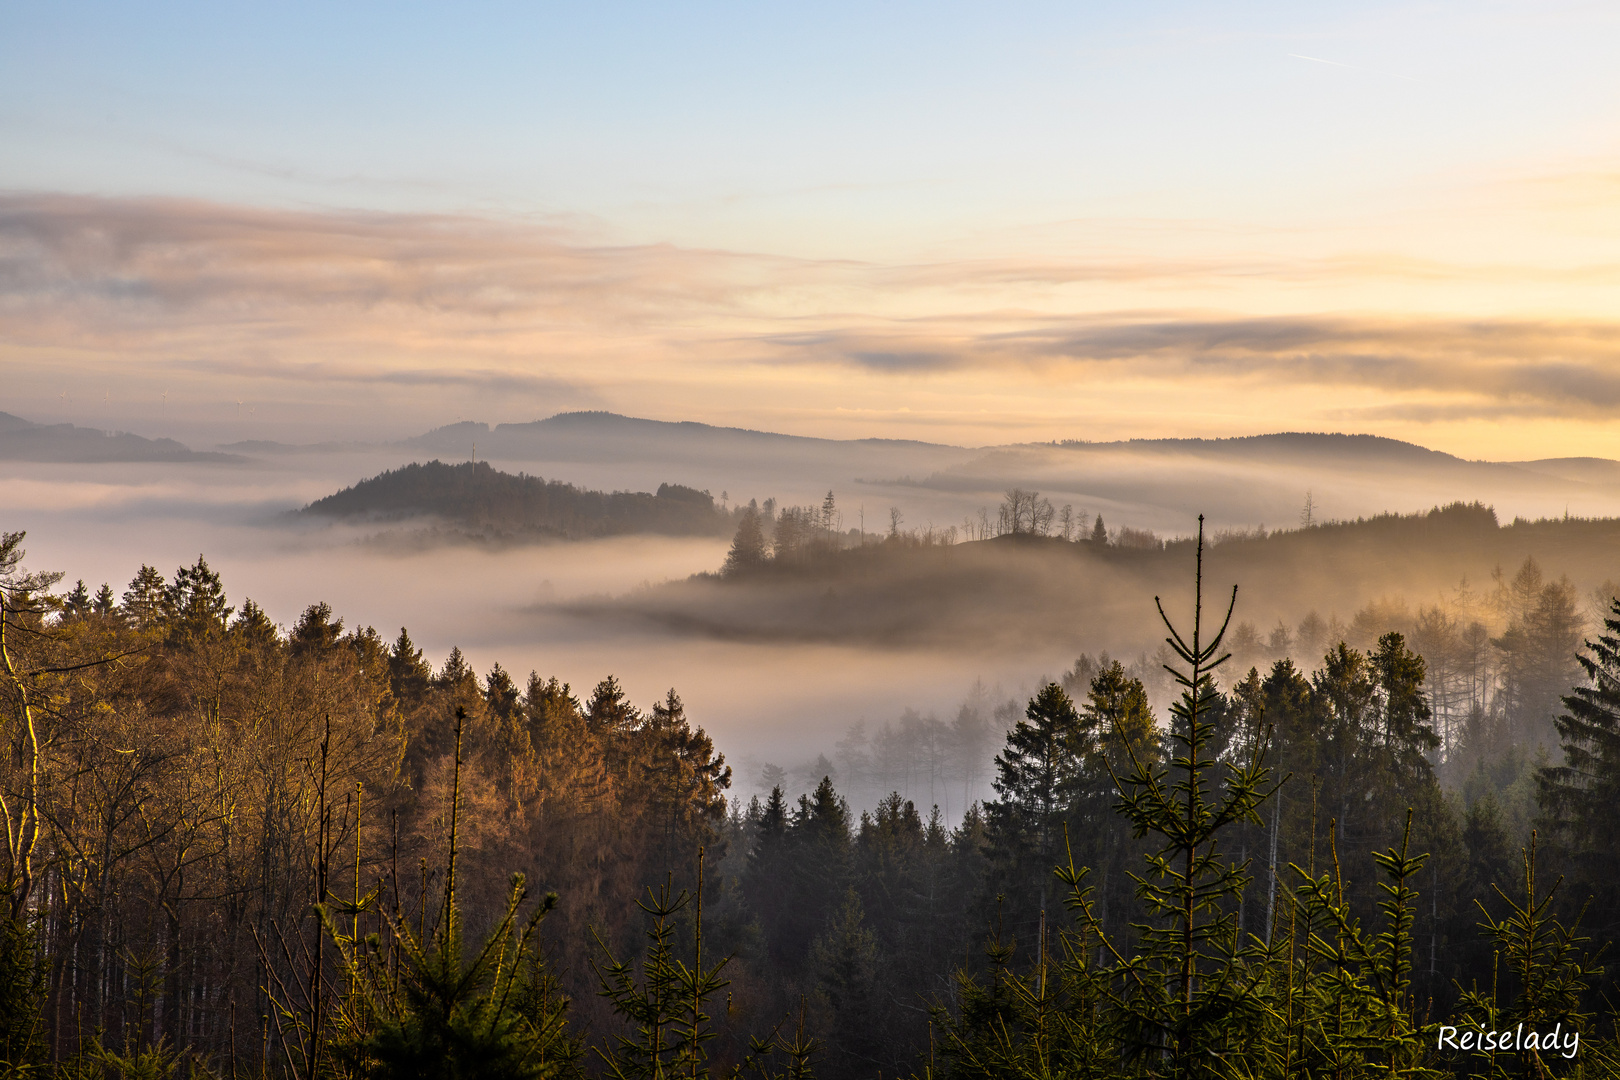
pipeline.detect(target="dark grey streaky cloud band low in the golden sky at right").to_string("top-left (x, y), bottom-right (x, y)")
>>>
top-left (754, 313), bottom-right (1620, 419)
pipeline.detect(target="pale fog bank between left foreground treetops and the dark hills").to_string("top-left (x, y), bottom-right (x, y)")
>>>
top-left (0, 455), bottom-right (1072, 789)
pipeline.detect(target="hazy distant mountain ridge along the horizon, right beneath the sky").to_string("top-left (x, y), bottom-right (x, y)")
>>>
top-left (15, 411), bottom-right (1620, 531)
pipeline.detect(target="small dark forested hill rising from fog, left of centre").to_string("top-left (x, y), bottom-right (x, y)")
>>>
top-left (301, 461), bottom-right (734, 539)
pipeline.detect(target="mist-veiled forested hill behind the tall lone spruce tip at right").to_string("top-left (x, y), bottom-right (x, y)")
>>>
top-left (591, 504), bottom-right (1620, 659)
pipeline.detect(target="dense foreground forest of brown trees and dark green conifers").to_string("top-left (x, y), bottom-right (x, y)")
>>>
top-left (0, 518), bottom-right (1620, 1078)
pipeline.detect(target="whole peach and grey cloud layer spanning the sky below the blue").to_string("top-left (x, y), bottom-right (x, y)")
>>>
top-left (0, 194), bottom-right (1620, 443)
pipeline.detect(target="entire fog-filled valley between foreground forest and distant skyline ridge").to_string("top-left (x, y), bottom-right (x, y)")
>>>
top-left (9, 415), bottom-right (1620, 813)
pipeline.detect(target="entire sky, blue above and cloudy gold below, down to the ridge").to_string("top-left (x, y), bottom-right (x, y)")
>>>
top-left (0, 0), bottom-right (1620, 460)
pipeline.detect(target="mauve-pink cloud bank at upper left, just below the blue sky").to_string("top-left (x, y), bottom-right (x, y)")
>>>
top-left (0, 196), bottom-right (784, 319)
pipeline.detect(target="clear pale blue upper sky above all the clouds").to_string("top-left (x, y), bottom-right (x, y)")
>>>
top-left (0, 3), bottom-right (1620, 244)
